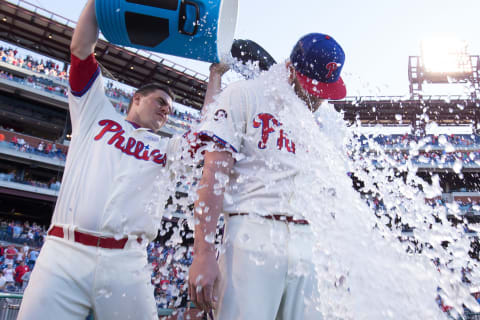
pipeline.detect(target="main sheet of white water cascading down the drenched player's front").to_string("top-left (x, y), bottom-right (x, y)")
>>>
top-left (278, 92), bottom-right (476, 319)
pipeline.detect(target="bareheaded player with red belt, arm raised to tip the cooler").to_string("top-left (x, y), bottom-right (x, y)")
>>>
top-left (18, 0), bottom-right (214, 320)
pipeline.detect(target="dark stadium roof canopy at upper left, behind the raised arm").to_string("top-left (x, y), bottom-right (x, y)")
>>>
top-left (0, 0), bottom-right (208, 109)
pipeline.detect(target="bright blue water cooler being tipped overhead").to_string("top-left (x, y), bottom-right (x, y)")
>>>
top-left (95, 0), bottom-right (238, 62)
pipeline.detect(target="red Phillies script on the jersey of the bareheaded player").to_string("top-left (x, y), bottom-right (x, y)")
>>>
top-left (94, 120), bottom-right (167, 167)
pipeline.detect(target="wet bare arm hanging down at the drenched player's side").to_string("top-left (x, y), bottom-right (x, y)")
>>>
top-left (188, 151), bottom-right (234, 311)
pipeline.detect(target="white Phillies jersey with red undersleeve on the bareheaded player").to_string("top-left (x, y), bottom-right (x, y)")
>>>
top-left (52, 55), bottom-right (176, 240)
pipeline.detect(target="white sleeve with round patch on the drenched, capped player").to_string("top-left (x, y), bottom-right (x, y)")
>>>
top-left (195, 84), bottom-right (247, 153)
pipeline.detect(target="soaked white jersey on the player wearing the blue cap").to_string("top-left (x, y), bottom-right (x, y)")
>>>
top-left (197, 64), bottom-right (306, 216)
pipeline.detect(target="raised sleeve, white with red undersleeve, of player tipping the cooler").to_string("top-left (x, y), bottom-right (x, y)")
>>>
top-left (68, 54), bottom-right (108, 135)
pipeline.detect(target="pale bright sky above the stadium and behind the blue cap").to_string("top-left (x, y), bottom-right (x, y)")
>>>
top-left (19, 0), bottom-right (480, 95)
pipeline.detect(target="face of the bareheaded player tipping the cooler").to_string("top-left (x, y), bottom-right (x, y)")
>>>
top-left (136, 90), bottom-right (172, 131)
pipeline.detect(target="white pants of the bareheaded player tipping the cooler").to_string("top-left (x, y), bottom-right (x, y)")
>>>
top-left (17, 236), bottom-right (158, 320)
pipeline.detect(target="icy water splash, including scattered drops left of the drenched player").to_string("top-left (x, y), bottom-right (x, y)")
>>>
top-left (162, 59), bottom-right (480, 320)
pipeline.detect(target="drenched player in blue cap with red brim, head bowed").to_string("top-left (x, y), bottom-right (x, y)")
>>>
top-left (189, 33), bottom-right (346, 320)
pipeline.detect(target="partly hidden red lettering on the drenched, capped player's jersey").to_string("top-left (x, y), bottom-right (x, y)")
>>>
top-left (253, 113), bottom-right (295, 153)
